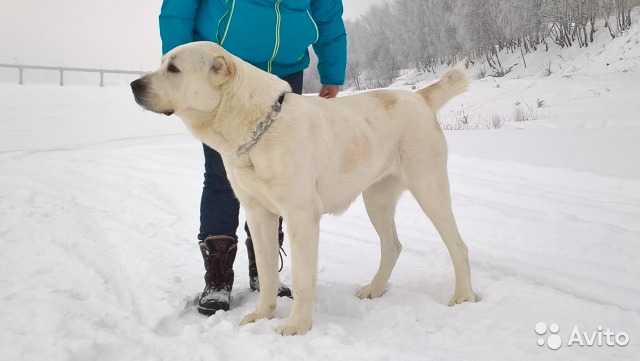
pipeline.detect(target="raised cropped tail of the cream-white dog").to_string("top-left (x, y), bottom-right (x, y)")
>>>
top-left (418, 67), bottom-right (469, 112)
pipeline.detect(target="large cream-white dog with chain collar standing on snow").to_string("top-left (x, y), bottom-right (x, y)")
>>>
top-left (131, 42), bottom-right (476, 335)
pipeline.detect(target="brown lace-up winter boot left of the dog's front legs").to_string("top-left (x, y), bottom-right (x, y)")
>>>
top-left (198, 236), bottom-right (238, 316)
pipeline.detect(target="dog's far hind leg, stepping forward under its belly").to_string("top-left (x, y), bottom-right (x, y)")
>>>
top-left (356, 176), bottom-right (404, 299)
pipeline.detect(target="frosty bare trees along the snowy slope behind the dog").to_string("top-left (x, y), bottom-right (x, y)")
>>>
top-left (347, 0), bottom-right (640, 88)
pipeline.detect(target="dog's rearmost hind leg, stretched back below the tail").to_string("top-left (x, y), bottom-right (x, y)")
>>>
top-left (403, 152), bottom-right (477, 306)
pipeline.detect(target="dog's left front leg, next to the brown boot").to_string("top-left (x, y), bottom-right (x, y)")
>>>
top-left (240, 203), bottom-right (280, 325)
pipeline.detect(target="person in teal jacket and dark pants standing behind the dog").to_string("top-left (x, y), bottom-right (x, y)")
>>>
top-left (160, 0), bottom-right (347, 315)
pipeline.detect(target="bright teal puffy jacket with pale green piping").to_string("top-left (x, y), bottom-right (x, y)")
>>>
top-left (160, 0), bottom-right (347, 85)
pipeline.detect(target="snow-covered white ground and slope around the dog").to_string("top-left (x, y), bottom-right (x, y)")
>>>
top-left (0, 18), bottom-right (640, 361)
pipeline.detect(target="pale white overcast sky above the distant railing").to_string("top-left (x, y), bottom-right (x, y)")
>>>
top-left (0, 0), bottom-right (384, 70)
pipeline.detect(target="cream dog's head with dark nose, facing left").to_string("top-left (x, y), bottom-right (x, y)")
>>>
top-left (131, 41), bottom-right (237, 115)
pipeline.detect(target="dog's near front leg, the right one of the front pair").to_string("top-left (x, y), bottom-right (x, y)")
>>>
top-left (276, 210), bottom-right (320, 336)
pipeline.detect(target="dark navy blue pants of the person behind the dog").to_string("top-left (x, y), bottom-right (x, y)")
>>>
top-left (198, 72), bottom-right (302, 241)
